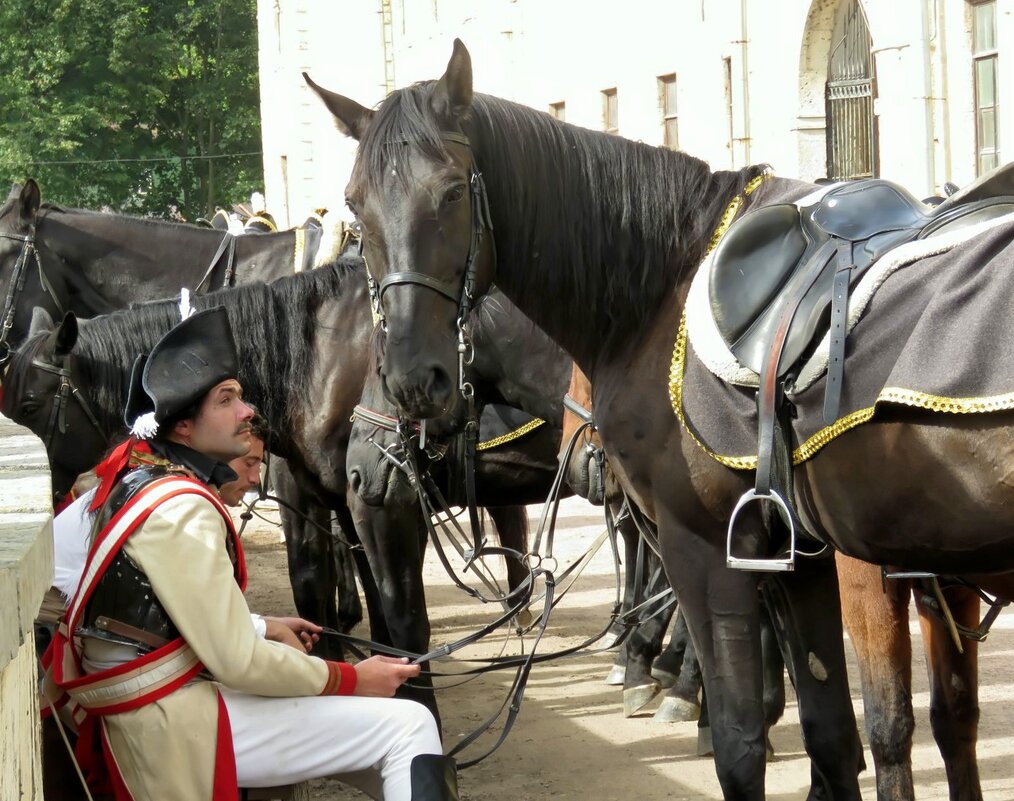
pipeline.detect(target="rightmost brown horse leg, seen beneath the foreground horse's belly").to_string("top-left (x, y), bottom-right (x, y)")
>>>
top-left (915, 587), bottom-right (983, 801)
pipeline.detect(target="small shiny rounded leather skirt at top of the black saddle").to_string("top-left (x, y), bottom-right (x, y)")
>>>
top-left (804, 178), bottom-right (930, 242)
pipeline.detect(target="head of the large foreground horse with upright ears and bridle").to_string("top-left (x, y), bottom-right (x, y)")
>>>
top-left (306, 41), bottom-right (495, 420)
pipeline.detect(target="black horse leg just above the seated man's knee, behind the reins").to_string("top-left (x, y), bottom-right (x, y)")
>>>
top-left (349, 492), bottom-right (440, 726)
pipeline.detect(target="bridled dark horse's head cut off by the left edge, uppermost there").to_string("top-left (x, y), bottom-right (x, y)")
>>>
top-left (0, 178), bottom-right (60, 364)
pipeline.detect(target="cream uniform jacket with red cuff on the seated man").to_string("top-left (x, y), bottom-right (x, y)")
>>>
top-left (92, 495), bottom-right (354, 801)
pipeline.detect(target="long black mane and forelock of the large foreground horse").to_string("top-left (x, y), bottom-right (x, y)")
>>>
top-left (353, 81), bottom-right (766, 354)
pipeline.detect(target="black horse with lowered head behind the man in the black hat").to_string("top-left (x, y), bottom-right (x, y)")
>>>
top-left (2, 260), bottom-right (382, 656)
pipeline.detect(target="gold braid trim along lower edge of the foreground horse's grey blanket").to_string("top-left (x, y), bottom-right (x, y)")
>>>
top-left (669, 314), bottom-right (1014, 470)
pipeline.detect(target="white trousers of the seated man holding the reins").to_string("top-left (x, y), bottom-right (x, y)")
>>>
top-left (221, 687), bottom-right (443, 801)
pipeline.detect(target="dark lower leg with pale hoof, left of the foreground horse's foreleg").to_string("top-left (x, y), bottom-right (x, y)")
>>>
top-left (624, 547), bottom-right (674, 718)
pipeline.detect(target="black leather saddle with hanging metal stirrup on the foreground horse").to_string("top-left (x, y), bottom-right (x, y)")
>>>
top-left (708, 163), bottom-right (1014, 571)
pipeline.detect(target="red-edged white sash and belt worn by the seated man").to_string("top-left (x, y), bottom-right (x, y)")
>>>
top-left (43, 476), bottom-right (246, 801)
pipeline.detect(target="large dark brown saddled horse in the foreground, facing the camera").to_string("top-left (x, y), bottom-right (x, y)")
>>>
top-left (302, 42), bottom-right (1014, 799)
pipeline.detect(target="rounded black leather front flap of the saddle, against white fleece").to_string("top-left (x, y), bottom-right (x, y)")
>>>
top-left (708, 204), bottom-right (807, 347)
